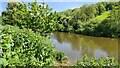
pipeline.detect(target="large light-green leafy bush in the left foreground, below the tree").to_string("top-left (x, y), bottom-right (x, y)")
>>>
top-left (0, 25), bottom-right (65, 66)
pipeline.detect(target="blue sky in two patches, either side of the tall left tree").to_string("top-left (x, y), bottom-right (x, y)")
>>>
top-left (0, 0), bottom-right (96, 15)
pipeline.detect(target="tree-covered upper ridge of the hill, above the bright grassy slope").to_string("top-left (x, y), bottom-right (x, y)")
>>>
top-left (59, 2), bottom-right (119, 22)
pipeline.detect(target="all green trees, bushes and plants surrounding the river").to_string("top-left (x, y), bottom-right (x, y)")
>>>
top-left (0, 2), bottom-right (120, 66)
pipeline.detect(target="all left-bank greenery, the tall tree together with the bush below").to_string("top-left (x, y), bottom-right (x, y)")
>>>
top-left (0, 2), bottom-right (67, 67)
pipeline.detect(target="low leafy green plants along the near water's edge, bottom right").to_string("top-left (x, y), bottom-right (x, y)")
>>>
top-left (75, 55), bottom-right (118, 68)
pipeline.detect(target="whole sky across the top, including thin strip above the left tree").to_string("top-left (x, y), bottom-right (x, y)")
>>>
top-left (0, 0), bottom-right (118, 15)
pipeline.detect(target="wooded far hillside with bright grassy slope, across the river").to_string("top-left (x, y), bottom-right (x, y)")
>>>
top-left (57, 2), bottom-right (120, 37)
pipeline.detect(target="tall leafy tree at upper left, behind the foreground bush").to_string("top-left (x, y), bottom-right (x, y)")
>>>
top-left (2, 2), bottom-right (58, 35)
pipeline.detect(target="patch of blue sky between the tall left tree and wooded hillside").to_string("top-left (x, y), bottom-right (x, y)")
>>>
top-left (47, 2), bottom-right (96, 11)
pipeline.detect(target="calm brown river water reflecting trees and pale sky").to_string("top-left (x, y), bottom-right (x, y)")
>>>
top-left (51, 32), bottom-right (120, 64)
